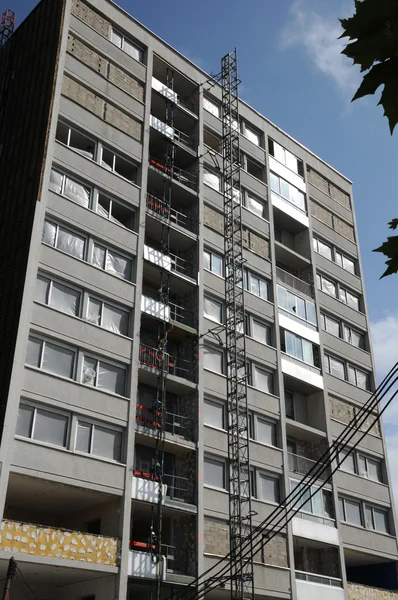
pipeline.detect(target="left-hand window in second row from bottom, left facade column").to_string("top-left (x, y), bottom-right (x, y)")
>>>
top-left (25, 335), bottom-right (76, 379)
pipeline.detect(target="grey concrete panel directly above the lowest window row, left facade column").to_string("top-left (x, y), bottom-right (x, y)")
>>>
top-left (21, 368), bottom-right (129, 426)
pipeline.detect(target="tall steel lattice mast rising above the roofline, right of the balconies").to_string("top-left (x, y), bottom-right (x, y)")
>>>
top-left (221, 49), bottom-right (254, 600)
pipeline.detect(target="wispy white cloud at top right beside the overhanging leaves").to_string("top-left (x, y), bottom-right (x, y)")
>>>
top-left (280, 0), bottom-right (360, 96)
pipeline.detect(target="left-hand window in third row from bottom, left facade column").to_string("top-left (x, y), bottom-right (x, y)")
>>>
top-left (35, 275), bottom-right (82, 317)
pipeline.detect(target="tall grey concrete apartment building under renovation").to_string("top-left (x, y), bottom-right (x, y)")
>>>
top-left (0, 0), bottom-right (398, 600)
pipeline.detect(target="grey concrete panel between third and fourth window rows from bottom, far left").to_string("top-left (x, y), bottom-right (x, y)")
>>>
top-left (40, 244), bottom-right (135, 304)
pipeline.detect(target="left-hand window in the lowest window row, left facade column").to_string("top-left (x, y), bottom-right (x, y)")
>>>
top-left (16, 402), bottom-right (69, 447)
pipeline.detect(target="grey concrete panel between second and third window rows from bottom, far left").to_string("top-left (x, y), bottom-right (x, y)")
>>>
top-left (32, 304), bottom-right (132, 363)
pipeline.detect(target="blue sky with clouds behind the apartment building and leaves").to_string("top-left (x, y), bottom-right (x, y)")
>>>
top-left (10, 0), bottom-right (398, 486)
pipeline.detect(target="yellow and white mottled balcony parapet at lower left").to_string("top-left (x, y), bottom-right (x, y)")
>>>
top-left (0, 520), bottom-right (118, 567)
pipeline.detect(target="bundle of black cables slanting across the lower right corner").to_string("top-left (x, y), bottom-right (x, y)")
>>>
top-left (166, 363), bottom-right (398, 599)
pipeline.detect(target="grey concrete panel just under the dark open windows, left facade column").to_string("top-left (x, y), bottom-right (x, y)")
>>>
top-left (54, 143), bottom-right (140, 206)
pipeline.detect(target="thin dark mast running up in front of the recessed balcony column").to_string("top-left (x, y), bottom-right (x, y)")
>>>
top-left (150, 69), bottom-right (175, 600)
